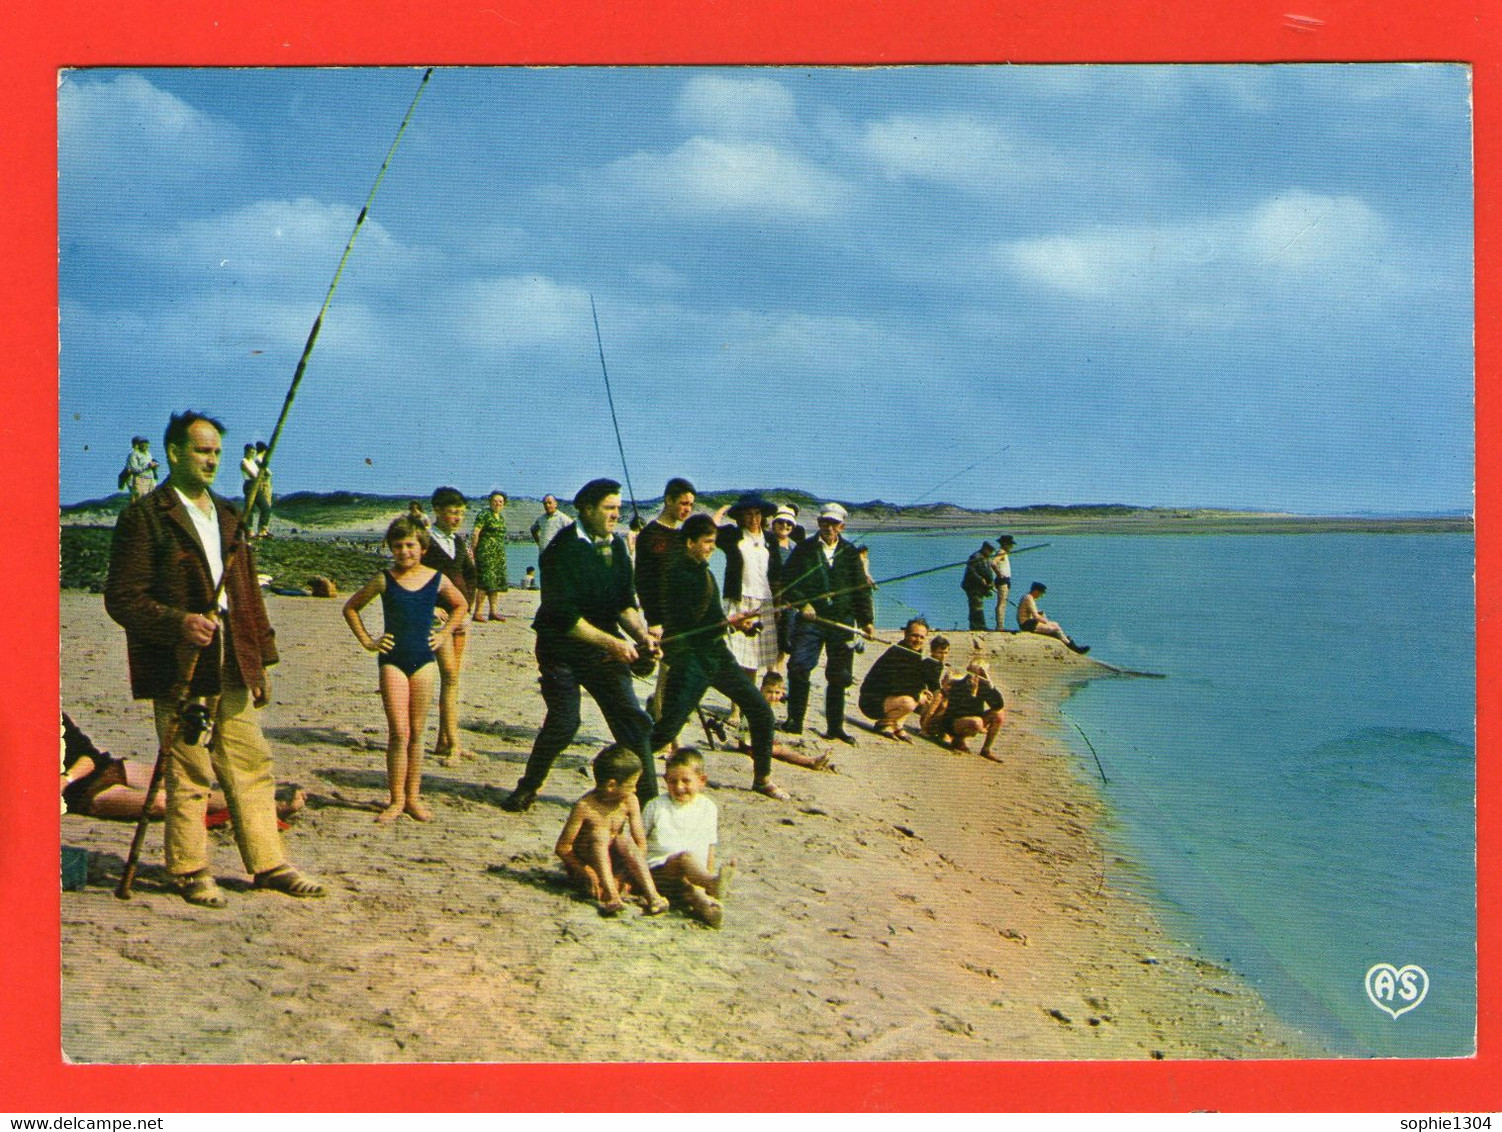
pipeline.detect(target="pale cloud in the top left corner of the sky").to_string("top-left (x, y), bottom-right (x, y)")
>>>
top-left (57, 72), bottom-right (246, 181)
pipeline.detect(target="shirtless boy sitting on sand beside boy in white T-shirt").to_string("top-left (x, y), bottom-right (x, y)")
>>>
top-left (553, 743), bottom-right (668, 916)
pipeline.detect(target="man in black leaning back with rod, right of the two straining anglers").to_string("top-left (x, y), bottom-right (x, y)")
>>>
top-left (652, 515), bottom-right (789, 802)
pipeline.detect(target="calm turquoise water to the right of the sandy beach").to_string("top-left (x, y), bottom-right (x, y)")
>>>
top-left (870, 533), bottom-right (1476, 1057)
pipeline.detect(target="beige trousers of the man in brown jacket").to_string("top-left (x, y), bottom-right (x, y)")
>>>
top-left (152, 688), bottom-right (287, 874)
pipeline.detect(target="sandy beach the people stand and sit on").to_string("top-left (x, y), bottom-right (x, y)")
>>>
top-left (60, 592), bottom-right (1317, 1063)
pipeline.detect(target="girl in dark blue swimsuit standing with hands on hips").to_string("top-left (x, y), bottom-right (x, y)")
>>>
top-left (344, 515), bottom-right (469, 823)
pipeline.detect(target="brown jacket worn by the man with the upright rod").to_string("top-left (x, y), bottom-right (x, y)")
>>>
top-left (104, 483), bottom-right (278, 700)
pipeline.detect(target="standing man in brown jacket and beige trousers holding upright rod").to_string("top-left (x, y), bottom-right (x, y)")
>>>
top-left (105, 411), bottom-right (324, 908)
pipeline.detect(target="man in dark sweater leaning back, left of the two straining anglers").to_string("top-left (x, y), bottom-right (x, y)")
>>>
top-left (500, 479), bottom-right (659, 814)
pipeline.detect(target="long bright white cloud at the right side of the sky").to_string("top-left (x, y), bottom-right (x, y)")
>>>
top-left (993, 189), bottom-right (1401, 314)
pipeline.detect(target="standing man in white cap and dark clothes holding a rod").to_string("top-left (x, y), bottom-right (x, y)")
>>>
top-left (783, 503), bottom-right (876, 743)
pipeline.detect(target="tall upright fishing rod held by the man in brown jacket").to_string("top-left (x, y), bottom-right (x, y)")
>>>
top-left (114, 68), bottom-right (433, 901)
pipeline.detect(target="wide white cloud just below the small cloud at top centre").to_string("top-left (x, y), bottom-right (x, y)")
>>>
top-left (607, 137), bottom-right (850, 218)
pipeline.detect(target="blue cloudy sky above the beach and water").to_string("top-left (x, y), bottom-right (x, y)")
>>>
top-left (59, 65), bottom-right (1473, 513)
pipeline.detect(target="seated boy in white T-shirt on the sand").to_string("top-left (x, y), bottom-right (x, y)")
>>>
top-left (641, 746), bottom-right (734, 928)
